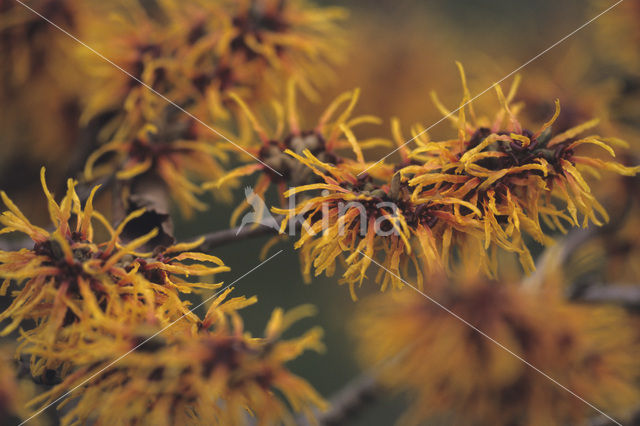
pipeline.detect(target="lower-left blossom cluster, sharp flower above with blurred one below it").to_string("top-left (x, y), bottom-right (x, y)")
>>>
top-left (0, 168), bottom-right (324, 424)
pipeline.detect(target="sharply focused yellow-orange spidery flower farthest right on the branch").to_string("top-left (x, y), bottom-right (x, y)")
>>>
top-left (400, 65), bottom-right (640, 271)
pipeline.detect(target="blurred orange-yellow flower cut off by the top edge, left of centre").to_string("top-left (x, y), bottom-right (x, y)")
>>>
top-left (161, 0), bottom-right (346, 116)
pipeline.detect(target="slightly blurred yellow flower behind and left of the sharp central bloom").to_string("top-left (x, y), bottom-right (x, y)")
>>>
top-left (211, 80), bottom-right (387, 225)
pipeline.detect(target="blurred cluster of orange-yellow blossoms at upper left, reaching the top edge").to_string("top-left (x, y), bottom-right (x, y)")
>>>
top-left (84, 0), bottom-right (350, 217)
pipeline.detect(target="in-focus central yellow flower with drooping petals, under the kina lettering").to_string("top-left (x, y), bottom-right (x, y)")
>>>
top-left (272, 150), bottom-right (484, 300)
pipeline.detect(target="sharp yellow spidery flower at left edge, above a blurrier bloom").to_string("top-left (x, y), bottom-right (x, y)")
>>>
top-left (0, 168), bottom-right (229, 374)
